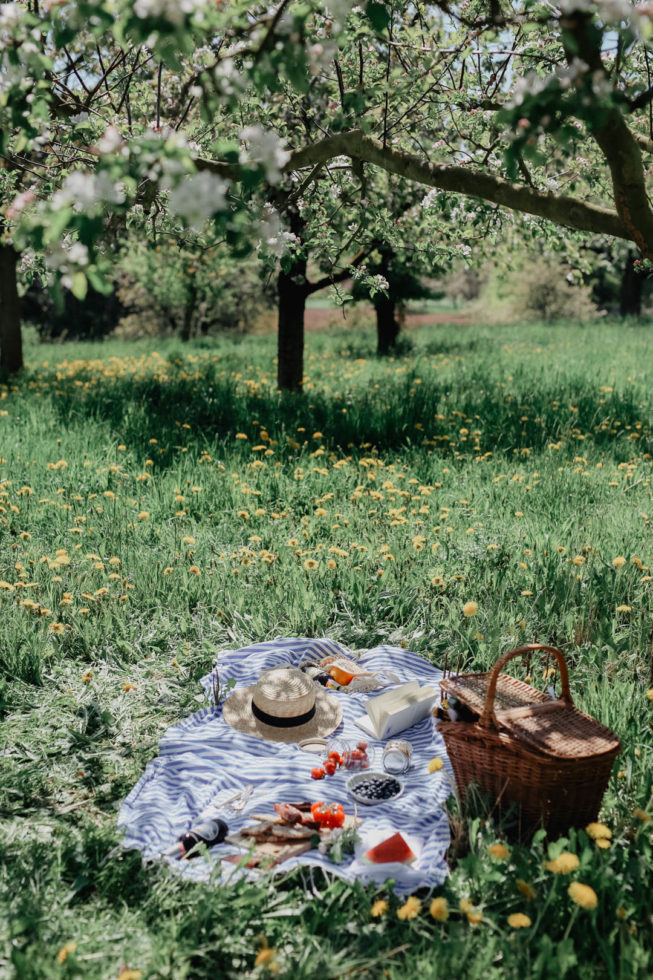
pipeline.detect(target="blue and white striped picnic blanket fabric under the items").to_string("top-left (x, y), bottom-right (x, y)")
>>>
top-left (118, 638), bottom-right (452, 894)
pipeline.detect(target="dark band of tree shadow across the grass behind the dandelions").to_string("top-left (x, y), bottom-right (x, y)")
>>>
top-left (16, 356), bottom-right (653, 466)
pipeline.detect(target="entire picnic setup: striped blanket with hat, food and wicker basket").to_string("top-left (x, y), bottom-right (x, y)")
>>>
top-left (118, 638), bottom-right (620, 894)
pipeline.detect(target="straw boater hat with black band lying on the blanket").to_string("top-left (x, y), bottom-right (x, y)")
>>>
top-left (222, 667), bottom-right (342, 742)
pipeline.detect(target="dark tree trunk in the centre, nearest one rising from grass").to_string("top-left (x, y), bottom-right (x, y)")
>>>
top-left (277, 259), bottom-right (308, 391)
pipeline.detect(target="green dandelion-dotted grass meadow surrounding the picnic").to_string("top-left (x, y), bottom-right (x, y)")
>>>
top-left (0, 324), bottom-right (653, 980)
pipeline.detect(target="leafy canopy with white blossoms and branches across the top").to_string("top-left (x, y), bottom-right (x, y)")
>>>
top-left (0, 0), bottom-right (653, 372)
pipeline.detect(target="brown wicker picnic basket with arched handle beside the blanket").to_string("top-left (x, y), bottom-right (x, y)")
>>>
top-left (437, 643), bottom-right (620, 834)
